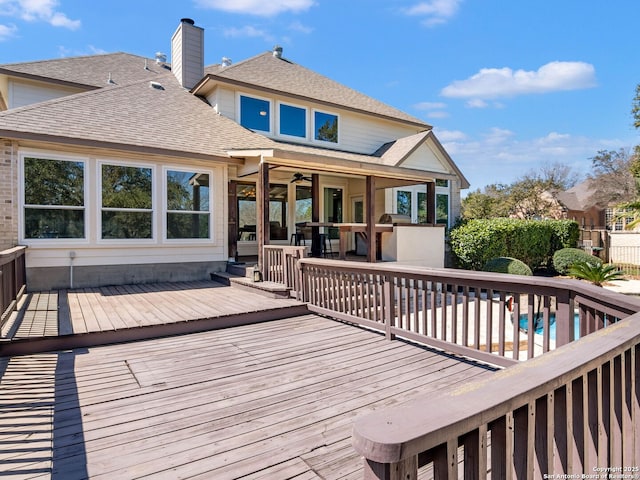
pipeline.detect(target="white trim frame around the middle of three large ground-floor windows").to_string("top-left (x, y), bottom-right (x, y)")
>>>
top-left (94, 158), bottom-right (158, 245)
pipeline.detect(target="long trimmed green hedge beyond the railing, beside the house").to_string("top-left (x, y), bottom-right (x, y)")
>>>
top-left (449, 218), bottom-right (579, 270)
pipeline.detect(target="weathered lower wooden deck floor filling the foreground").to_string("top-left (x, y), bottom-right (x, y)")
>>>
top-left (0, 314), bottom-right (492, 480)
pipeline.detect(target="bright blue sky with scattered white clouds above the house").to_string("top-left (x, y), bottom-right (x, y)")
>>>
top-left (0, 0), bottom-right (640, 191)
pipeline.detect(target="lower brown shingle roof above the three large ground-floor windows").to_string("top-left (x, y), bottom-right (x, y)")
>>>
top-left (0, 75), bottom-right (274, 157)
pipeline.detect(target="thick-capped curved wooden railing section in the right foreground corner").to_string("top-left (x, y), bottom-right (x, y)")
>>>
top-left (353, 315), bottom-right (640, 480)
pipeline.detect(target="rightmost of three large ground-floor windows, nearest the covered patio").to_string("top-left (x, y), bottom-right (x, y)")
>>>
top-left (166, 170), bottom-right (211, 239)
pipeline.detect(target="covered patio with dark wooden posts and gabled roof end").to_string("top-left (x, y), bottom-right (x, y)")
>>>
top-left (228, 131), bottom-right (466, 276)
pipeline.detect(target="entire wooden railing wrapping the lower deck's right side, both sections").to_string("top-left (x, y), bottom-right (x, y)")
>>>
top-left (288, 259), bottom-right (640, 480)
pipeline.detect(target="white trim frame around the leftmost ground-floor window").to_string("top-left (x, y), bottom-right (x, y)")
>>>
top-left (18, 149), bottom-right (92, 246)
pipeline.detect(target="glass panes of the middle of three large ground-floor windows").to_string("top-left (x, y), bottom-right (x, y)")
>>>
top-left (101, 164), bottom-right (153, 240)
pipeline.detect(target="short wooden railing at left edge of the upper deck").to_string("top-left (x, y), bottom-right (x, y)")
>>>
top-left (0, 247), bottom-right (26, 327)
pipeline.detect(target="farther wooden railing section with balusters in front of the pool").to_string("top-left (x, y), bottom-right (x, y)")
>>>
top-left (300, 258), bottom-right (640, 366)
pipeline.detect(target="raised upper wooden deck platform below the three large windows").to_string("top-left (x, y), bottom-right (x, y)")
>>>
top-left (0, 281), bottom-right (306, 355)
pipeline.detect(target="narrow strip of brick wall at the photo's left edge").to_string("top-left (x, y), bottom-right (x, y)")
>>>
top-left (0, 140), bottom-right (18, 250)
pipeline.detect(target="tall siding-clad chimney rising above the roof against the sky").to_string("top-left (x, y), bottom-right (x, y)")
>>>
top-left (171, 18), bottom-right (204, 89)
